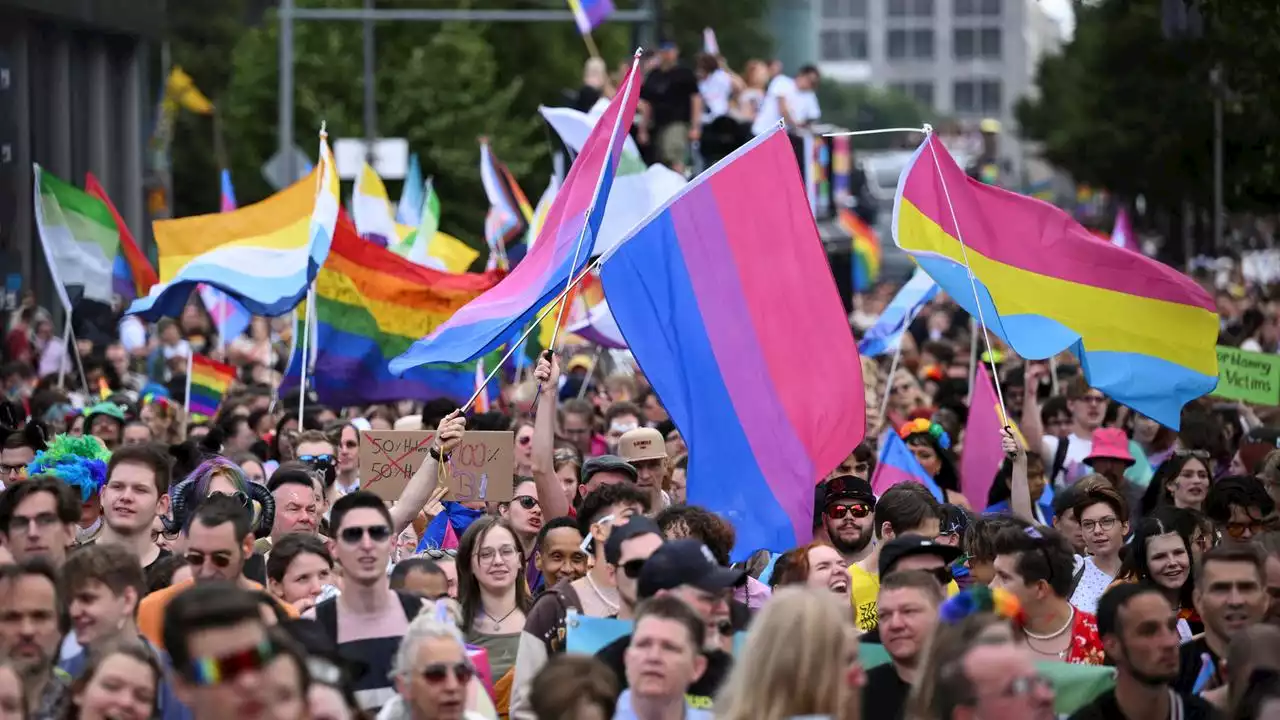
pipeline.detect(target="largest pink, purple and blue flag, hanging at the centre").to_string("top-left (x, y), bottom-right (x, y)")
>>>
top-left (602, 127), bottom-right (865, 560)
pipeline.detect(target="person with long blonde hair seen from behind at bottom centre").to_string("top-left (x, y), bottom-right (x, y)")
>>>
top-left (716, 587), bottom-right (867, 720)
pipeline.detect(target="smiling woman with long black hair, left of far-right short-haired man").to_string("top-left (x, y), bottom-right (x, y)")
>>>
top-left (1112, 506), bottom-right (1204, 642)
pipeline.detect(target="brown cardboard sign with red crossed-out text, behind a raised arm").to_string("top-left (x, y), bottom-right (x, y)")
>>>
top-left (360, 430), bottom-right (516, 502)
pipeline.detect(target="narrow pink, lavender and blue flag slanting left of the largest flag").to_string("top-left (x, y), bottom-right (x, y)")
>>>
top-left (390, 55), bottom-right (640, 374)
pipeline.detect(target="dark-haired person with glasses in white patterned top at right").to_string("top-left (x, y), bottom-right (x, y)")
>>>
top-left (1071, 480), bottom-right (1129, 614)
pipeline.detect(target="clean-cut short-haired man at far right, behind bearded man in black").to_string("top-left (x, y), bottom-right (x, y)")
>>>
top-left (1172, 543), bottom-right (1267, 693)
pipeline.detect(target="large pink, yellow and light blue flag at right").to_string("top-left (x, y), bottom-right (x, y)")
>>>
top-left (893, 135), bottom-right (1219, 425)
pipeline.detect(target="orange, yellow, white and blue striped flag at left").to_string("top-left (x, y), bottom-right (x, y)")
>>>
top-left (128, 136), bottom-right (339, 320)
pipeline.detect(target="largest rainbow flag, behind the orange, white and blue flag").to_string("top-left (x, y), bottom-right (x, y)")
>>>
top-left (284, 215), bottom-right (502, 407)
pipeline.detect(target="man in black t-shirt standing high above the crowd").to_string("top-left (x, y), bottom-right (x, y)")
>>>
top-left (640, 41), bottom-right (703, 173)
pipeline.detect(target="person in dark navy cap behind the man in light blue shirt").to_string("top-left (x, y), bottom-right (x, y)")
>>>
top-left (595, 539), bottom-right (746, 710)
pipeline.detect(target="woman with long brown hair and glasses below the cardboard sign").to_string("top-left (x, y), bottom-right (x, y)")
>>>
top-left (458, 515), bottom-right (530, 711)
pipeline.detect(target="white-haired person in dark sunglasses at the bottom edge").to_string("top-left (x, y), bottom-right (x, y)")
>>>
top-left (378, 602), bottom-right (485, 720)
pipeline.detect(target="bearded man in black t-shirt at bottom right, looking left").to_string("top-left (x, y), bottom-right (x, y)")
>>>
top-left (1071, 583), bottom-right (1216, 720)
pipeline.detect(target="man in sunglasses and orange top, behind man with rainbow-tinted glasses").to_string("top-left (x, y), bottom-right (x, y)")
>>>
top-left (138, 493), bottom-right (298, 650)
